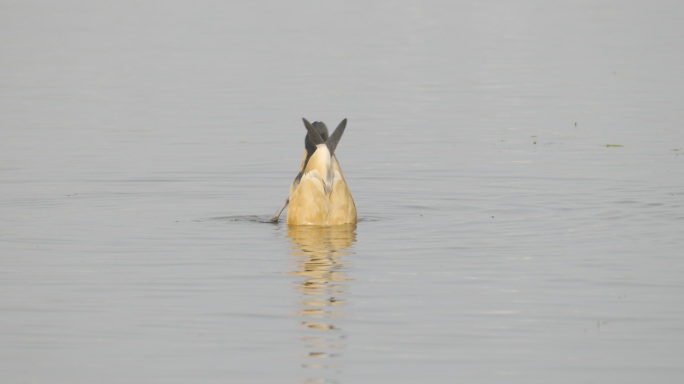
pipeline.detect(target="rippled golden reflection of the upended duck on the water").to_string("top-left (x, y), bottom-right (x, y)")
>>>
top-left (287, 224), bottom-right (356, 383)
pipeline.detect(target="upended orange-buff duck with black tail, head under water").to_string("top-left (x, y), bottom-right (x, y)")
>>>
top-left (271, 119), bottom-right (357, 225)
